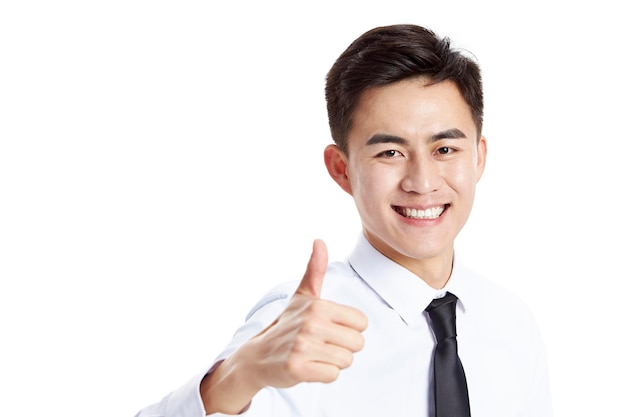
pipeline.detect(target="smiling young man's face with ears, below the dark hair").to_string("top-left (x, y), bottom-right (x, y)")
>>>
top-left (325, 79), bottom-right (486, 269)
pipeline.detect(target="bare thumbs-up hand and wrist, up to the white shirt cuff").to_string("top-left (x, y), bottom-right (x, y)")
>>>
top-left (200, 240), bottom-right (367, 414)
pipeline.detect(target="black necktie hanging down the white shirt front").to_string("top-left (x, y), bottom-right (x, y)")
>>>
top-left (426, 293), bottom-right (470, 417)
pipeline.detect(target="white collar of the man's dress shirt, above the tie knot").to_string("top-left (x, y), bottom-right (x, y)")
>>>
top-left (348, 234), bottom-right (472, 325)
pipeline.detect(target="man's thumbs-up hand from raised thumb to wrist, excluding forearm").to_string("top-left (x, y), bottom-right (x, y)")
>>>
top-left (248, 240), bottom-right (367, 388)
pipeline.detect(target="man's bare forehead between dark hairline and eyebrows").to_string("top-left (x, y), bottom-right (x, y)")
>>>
top-left (348, 77), bottom-right (477, 148)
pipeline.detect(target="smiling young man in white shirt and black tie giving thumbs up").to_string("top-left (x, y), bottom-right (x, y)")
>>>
top-left (139, 25), bottom-right (551, 417)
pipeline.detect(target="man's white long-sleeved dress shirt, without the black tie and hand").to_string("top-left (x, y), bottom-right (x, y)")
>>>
top-left (138, 232), bottom-right (552, 417)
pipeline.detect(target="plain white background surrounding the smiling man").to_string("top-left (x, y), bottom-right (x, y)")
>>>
top-left (0, 0), bottom-right (626, 416)
